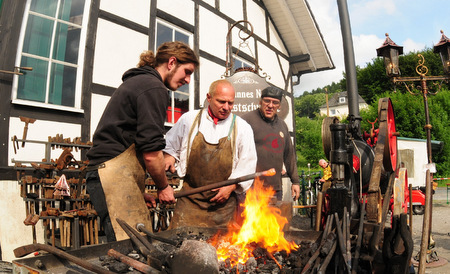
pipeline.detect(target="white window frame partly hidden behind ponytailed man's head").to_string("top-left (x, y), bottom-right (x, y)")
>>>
top-left (153, 18), bottom-right (195, 126)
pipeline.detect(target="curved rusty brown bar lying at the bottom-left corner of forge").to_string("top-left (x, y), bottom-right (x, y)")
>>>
top-left (14, 244), bottom-right (112, 274)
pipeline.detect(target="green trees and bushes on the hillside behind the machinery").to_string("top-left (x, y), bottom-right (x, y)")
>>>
top-left (295, 49), bottom-right (450, 177)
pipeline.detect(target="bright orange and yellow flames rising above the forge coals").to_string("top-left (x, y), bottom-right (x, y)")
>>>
top-left (211, 178), bottom-right (299, 266)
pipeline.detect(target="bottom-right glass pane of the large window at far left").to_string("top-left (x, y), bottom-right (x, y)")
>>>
top-left (48, 64), bottom-right (77, 107)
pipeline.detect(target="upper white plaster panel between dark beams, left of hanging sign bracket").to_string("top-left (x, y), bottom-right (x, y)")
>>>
top-left (199, 7), bottom-right (228, 60)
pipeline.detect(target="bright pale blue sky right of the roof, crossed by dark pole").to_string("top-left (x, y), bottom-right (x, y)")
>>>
top-left (294, 0), bottom-right (450, 96)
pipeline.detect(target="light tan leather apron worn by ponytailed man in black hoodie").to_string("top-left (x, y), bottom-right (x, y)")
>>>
top-left (98, 144), bottom-right (152, 241)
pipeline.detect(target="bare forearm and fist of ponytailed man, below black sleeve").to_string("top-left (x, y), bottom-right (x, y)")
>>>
top-left (143, 151), bottom-right (175, 204)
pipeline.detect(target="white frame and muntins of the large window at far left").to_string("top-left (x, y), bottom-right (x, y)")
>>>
top-left (11, 0), bottom-right (91, 113)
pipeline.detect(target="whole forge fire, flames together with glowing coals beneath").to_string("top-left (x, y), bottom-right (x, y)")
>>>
top-left (209, 179), bottom-right (310, 273)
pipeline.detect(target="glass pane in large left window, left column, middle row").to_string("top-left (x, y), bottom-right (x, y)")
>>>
top-left (23, 14), bottom-right (53, 57)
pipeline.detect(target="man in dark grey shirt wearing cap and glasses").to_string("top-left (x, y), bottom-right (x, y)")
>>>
top-left (242, 87), bottom-right (300, 200)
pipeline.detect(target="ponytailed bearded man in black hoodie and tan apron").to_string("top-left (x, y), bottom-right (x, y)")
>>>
top-left (86, 42), bottom-right (199, 241)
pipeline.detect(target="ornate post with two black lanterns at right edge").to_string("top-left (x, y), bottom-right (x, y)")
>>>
top-left (377, 31), bottom-right (450, 273)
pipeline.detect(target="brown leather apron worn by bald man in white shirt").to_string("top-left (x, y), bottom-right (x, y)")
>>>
top-left (169, 110), bottom-right (237, 229)
